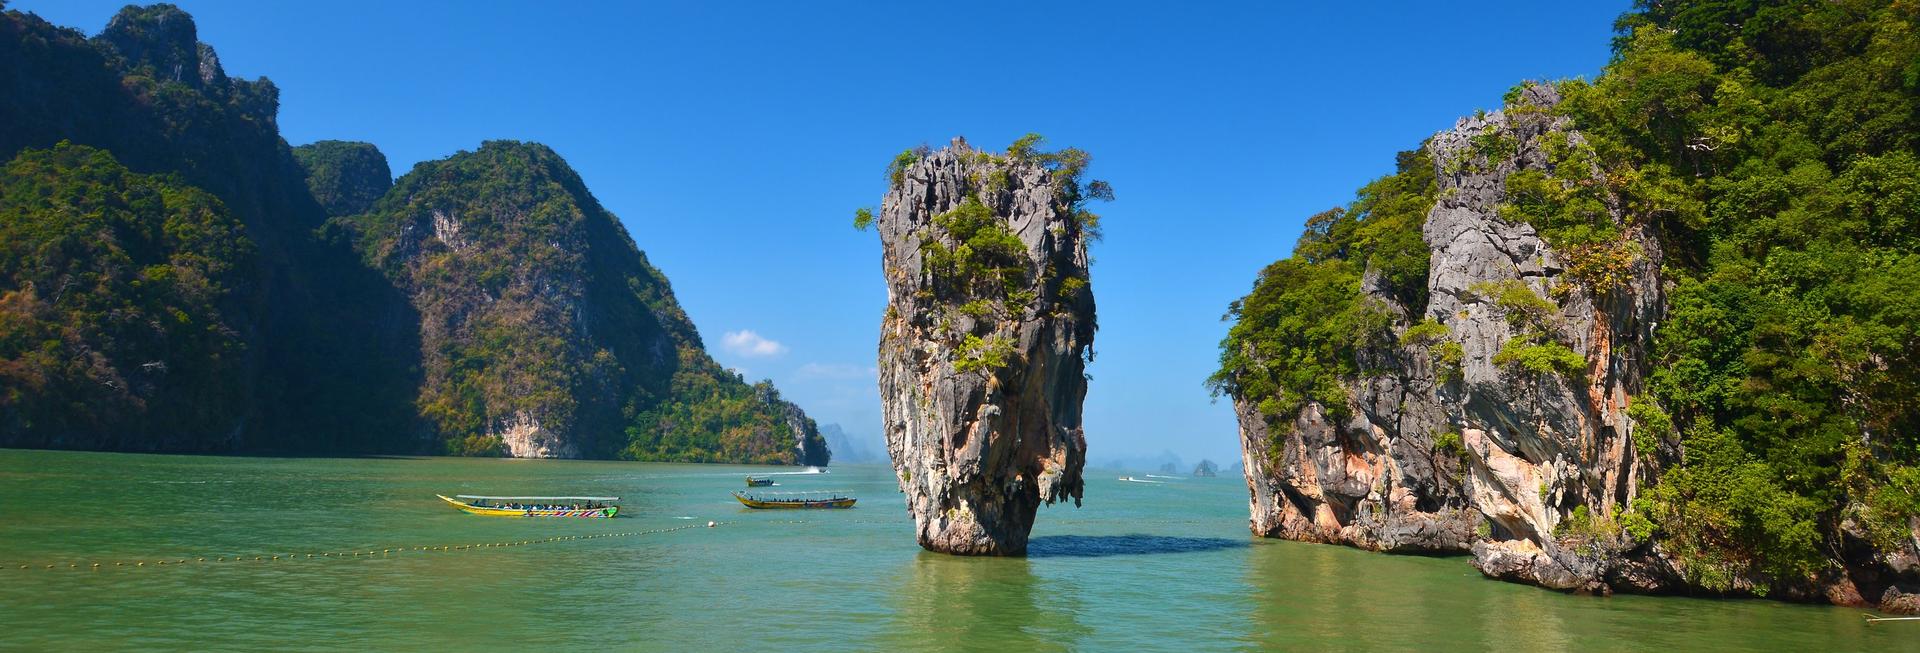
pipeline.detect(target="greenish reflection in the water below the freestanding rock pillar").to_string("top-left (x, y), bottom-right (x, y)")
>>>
top-left (879, 551), bottom-right (1092, 651)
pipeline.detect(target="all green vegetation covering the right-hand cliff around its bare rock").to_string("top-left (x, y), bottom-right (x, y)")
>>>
top-left (1213, 0), bottom-right (1920, 609)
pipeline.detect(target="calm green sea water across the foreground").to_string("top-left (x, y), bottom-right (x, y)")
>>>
top-left (0, 449), bottom-right (1920, 651)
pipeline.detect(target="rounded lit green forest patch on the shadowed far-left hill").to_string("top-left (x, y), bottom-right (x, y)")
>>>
top-left (0, 142), bottom-right (259, 449)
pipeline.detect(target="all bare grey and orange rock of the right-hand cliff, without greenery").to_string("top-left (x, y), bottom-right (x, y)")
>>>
top-left (1235, 86), bottom-right (1661, 590)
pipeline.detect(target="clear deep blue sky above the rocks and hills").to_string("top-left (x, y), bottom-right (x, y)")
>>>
top-left (22, 0), bottom-right (1630, 467)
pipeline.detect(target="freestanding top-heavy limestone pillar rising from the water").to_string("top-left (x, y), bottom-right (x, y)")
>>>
top-left (854, 134), bottom-right (1112, 555)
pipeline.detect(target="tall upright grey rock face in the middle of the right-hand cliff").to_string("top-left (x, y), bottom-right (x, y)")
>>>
top-left (1425, 86), bottom-right (1665, 590)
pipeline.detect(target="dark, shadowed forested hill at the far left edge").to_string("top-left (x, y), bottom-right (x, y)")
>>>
top-left (0, 4), bottom-right (419, 453)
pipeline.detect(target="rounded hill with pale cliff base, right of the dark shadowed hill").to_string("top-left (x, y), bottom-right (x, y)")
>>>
top-left (345, 140), bottom-right (829, 465)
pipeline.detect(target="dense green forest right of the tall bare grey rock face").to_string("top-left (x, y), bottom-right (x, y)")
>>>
top-left (1561, 2), bottom-right (1920, 590)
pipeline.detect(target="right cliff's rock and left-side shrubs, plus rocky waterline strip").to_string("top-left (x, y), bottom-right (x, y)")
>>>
top-left (1221, 85), bottom-right (1920, 611)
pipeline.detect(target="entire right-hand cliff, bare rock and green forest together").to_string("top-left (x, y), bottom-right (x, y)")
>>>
top-left (1212, 2), bottom-right (1920, 611)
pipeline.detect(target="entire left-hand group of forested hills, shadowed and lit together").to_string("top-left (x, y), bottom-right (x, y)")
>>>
top-left (0, 4), bottom-right (829, 465)
